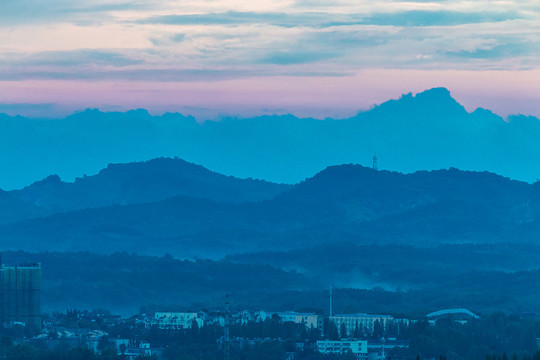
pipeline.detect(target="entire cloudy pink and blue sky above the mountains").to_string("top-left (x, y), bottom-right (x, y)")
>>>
top-left (0, 0), bottom-right (540, 120)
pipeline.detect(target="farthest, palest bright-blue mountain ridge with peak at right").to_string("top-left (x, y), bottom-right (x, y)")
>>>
top-left (0, 88), bottom-right (540, 190)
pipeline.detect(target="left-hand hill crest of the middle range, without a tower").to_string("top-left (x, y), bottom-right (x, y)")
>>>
top-left (10, 158), bottom-right (291, 213)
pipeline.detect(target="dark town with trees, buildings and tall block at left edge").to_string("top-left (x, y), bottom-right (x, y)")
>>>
top-left (0, 263), bottom-right (540, 360)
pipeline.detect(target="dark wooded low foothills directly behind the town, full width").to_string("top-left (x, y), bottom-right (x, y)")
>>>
top-left (3, 250), bottom-right (540, 318)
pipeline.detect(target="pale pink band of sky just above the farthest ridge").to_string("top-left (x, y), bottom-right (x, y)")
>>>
top-left (0, 69), bottom-right (540, 118)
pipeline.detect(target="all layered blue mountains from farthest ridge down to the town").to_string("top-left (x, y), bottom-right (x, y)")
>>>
top-left (0, 88), bottom-right (540, 313)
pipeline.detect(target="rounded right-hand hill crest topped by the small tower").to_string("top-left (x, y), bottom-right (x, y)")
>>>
top-left (276, 165), bottom-right (540, 221)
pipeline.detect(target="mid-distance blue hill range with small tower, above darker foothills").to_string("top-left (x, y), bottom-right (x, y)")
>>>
top-left (0, 159), bottom-right (540, 257)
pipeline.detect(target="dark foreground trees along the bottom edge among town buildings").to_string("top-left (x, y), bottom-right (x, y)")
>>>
top-left (0, 313), bottom-right (540, 360)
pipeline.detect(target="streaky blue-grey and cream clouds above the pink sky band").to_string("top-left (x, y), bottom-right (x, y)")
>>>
top-left (0, 0), bottom-right (540, 117)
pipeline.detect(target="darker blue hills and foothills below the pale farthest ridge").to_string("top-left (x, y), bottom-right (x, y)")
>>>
top-left (5, 158), bottom-right (540, 313)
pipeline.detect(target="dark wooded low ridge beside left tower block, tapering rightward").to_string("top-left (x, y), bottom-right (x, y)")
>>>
top-left (2, 252), bottom-right (308, 315)
